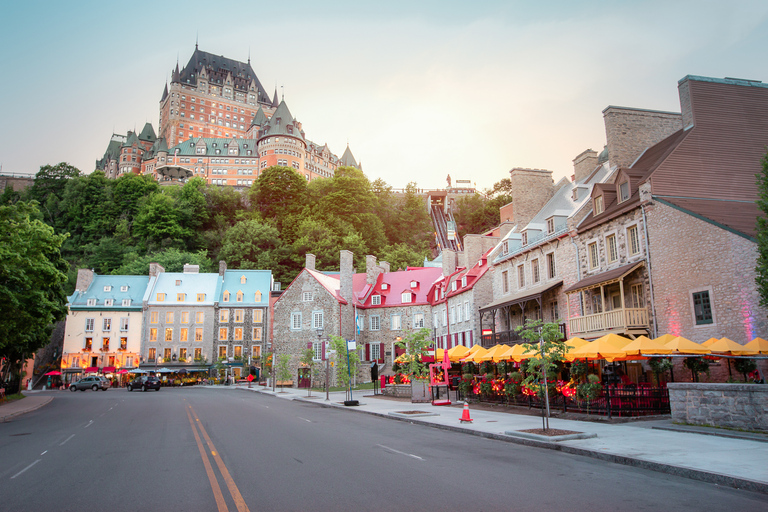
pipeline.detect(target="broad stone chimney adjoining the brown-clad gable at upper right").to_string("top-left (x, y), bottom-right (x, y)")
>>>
top-left (603, 106), bottom-right (683, 167)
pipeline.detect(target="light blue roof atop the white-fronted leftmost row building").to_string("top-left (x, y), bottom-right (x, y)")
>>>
top-left (69, 274), bottom-right (149, 311)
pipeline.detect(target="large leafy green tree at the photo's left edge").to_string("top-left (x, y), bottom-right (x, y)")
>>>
top-left (0, 201), bottom-right (67, 392)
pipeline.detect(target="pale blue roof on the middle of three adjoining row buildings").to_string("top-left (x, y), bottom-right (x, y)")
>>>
top-left (147, 272), bottom-right (221, 306)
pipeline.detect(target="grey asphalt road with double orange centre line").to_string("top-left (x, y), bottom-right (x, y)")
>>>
top-left (0, 388), bottom-right (768, 512)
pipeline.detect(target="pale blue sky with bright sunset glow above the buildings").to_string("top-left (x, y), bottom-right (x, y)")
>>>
top-left (0, 0), bottom-right (768, 190)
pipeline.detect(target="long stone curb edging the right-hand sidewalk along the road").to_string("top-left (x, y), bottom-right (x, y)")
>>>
top-left (293, 397), bottom-right (768, 494)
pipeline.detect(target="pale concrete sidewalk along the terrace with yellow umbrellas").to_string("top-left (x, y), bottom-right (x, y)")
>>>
top-left (237, 386), bottom-right (768, 493)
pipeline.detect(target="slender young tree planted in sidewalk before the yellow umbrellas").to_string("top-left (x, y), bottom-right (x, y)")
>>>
top-left (517, 319), bottom-right (568, 430)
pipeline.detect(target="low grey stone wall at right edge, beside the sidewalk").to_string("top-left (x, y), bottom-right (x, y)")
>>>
top-left (667, 382), bottom-right (768, 431)
